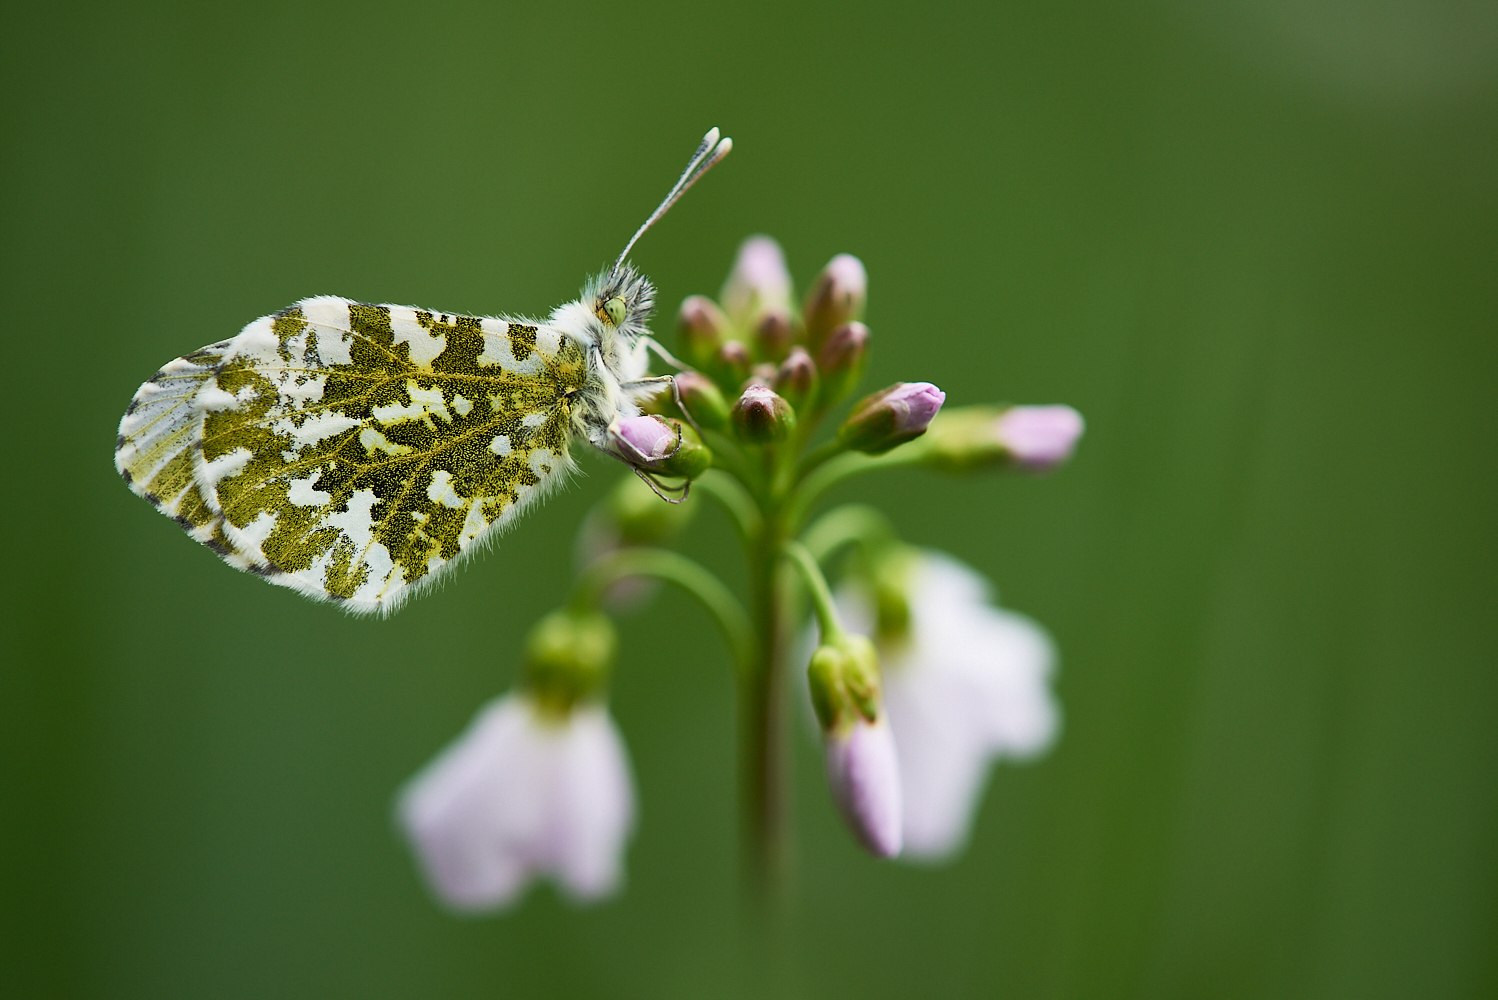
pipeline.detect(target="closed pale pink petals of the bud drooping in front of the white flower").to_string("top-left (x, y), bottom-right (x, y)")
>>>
top-left (825, 714), bottom-right (902, 858)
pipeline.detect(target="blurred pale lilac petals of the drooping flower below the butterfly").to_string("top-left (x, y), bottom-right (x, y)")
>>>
top-left (397, 692), bottom-right (635, 912)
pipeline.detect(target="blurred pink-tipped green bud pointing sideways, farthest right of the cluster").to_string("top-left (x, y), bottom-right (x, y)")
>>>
top-left (923, 406), bottom-right (1085, 472)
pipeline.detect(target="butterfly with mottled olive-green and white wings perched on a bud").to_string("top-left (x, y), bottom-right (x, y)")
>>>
top-left (115, 122), bottom-right (733, 612)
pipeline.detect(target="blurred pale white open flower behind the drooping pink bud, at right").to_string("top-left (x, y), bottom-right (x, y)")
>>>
top-left (837, 549), bottom-right (1061, 859)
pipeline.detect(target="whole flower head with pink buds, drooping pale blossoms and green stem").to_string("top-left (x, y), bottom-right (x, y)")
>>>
top-left (398, 237), bottom-right (1083, 910)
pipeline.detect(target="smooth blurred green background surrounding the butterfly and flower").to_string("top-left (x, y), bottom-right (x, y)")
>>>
top-left (0, 0), bottom-right (1498, 999)
